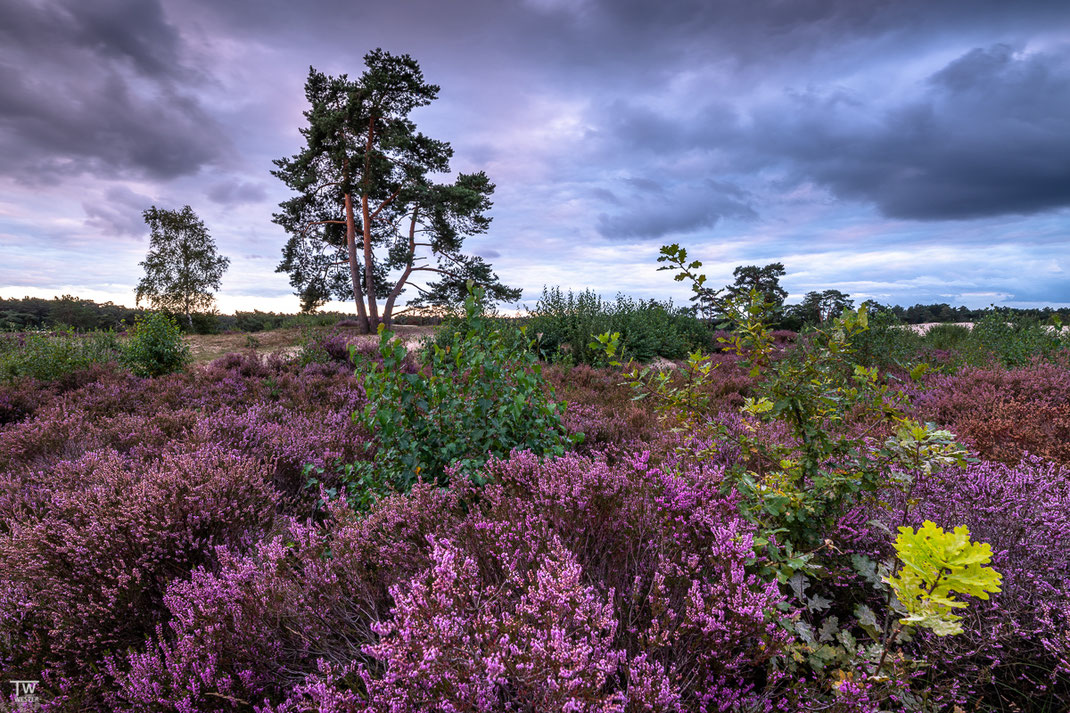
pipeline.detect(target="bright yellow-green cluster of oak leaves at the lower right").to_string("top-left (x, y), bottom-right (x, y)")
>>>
top-left (886, 520), bottom-right (1000, 636)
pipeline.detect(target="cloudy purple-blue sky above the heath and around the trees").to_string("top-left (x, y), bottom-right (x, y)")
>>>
top-left (0, 0), bottom-right (1070, 312)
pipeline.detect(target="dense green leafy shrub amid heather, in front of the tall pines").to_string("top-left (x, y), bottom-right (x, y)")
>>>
top-left (354, 288), bottom-right (582, 490)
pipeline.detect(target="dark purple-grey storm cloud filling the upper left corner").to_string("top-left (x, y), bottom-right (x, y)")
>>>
top-left (0, 0), bottom-right (228, 182)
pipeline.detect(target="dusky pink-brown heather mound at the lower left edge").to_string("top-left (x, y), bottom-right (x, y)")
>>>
top-left (0, 447), bottom-right (276, 708)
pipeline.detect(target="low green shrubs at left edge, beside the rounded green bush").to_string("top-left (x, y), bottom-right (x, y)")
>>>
top-left (0, 328), bottom-right (120, 381)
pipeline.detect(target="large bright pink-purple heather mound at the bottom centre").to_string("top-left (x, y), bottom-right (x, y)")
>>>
top-left (110, 447), bottom-right (784, 712)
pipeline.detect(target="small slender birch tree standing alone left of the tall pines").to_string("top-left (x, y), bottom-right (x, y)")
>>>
top-left (137, 206), bottom-right (230, 330)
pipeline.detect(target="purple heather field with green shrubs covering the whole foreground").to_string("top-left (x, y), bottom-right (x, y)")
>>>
top-left (0, 286), bottom-right (1070, 713)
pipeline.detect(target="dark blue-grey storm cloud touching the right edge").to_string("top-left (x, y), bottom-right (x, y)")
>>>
top-left (739, 45), bottom-right (1070, 221)
